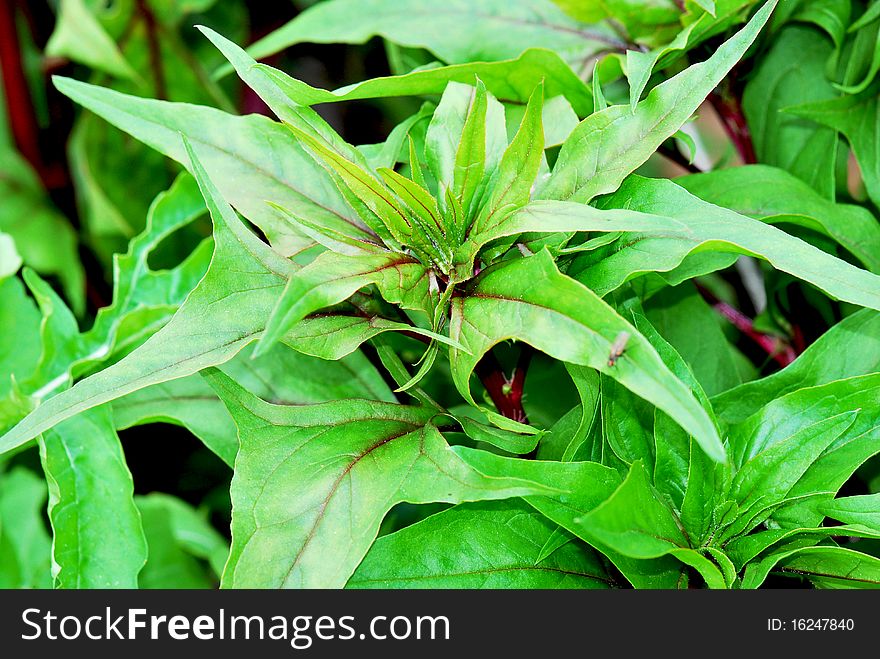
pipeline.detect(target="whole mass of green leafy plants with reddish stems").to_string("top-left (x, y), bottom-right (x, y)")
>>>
top-left (0, 0), bottom-right (880, 588)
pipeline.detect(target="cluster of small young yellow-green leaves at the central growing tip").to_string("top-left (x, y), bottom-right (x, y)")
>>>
top-left (254, 79), bottom-right (549, 388)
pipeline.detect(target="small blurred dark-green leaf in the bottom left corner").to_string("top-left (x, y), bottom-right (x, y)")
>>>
top-left (0, 467), bottom-right (52, 588)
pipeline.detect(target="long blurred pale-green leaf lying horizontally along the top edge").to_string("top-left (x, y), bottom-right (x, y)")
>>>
top-left (249, 0), bottom-right (623, 70)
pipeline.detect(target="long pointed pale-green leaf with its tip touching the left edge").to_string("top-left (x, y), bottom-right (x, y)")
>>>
top-left (0, 140), bottom-right (293, 454)
